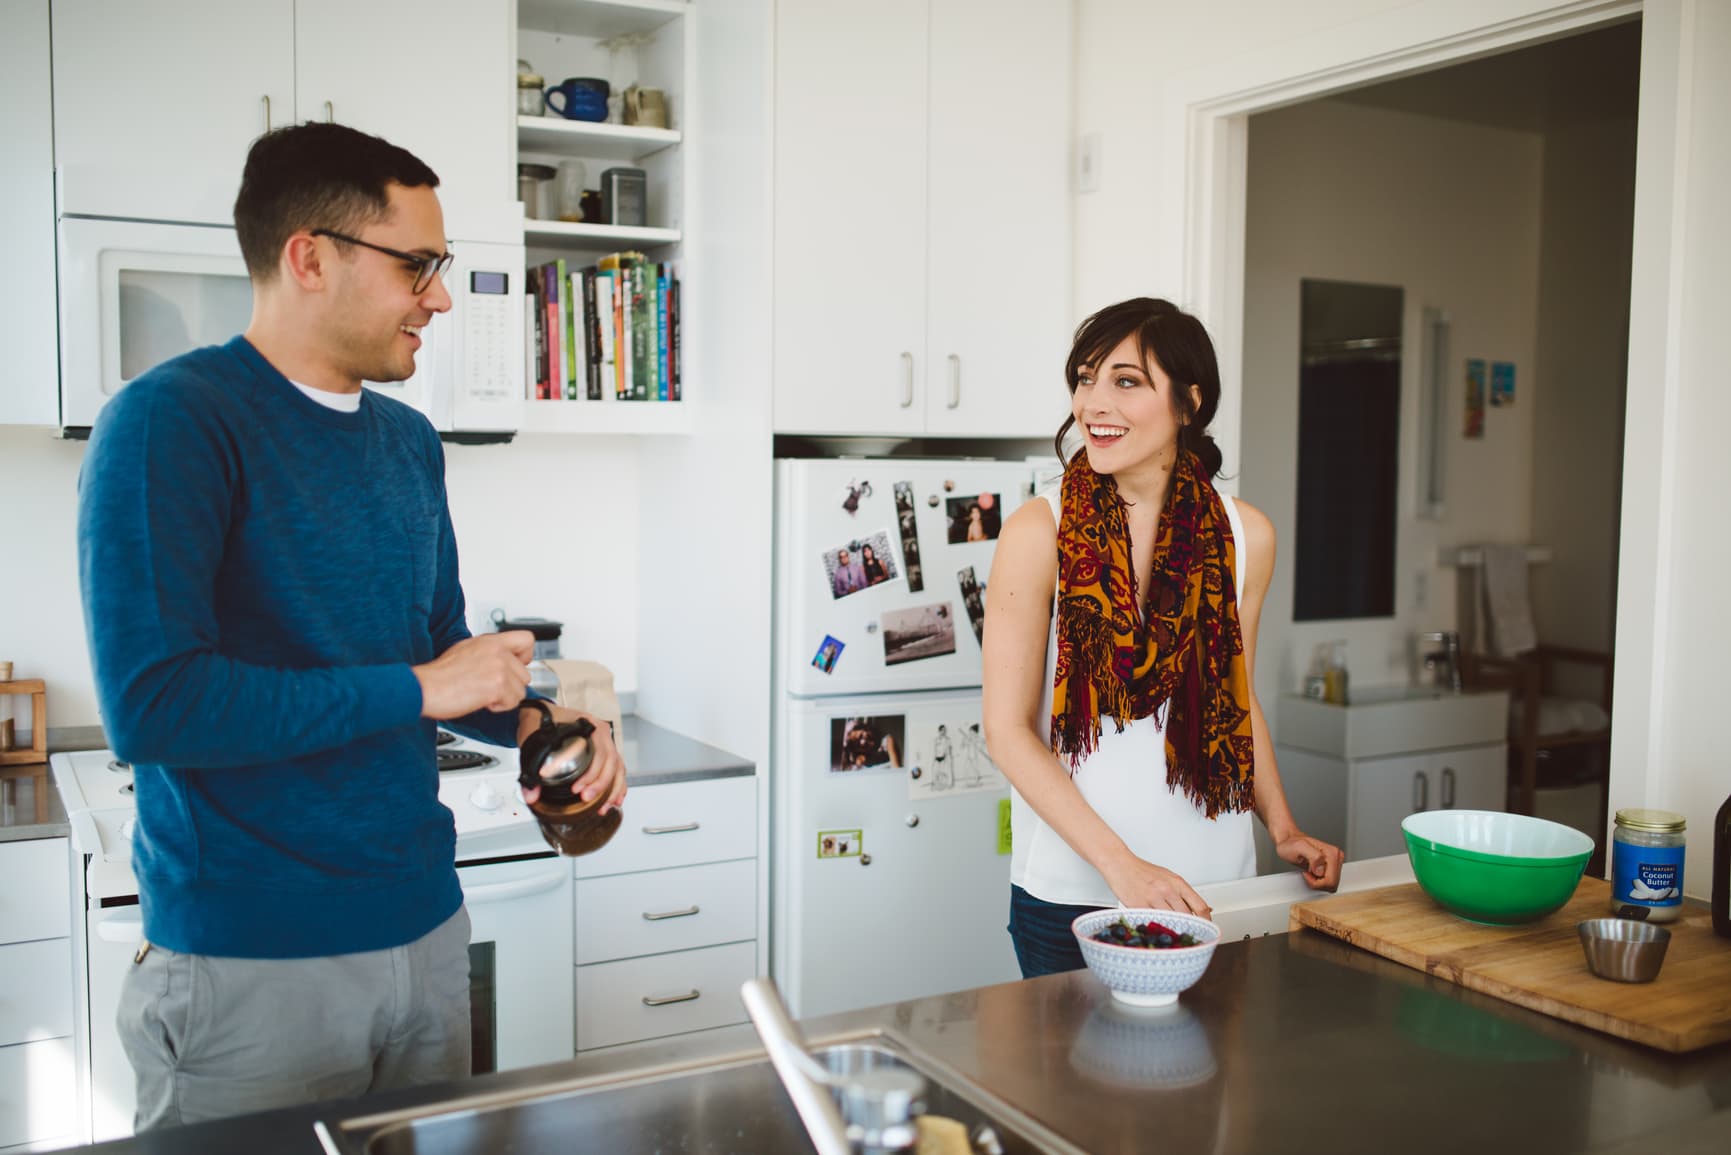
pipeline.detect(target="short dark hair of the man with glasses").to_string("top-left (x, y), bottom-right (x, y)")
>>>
top-left (234, 121), bottom-right (438, 281)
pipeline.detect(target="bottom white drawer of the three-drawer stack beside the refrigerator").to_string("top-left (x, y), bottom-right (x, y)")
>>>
top-left (576, 942), bottom-right (756, 1051)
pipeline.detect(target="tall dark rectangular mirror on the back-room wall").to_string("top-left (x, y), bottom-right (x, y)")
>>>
top-left (1293, 281), bottom-right (1404, 622)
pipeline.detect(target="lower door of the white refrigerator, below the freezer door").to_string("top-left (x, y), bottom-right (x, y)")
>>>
top-left (774, 693), bottom-right (1020, 1018)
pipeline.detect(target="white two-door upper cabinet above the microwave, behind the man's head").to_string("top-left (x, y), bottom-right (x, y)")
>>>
top-left (52, 0), bottom-right (516, 241)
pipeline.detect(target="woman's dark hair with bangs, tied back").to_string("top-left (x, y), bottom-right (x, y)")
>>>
top-left (1052, 296), bottom-right (1224, 478)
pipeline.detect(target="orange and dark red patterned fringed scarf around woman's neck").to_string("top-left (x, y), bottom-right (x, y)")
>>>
top-left (1052, 450), bottom-right (1255, 817)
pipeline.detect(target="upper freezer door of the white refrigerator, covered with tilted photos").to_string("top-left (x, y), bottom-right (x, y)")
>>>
top-left (775, 459), bottom-right (1039, 698)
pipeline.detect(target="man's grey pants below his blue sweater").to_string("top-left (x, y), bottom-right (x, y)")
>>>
top-left (118, 907), bottom-right (469, 1131)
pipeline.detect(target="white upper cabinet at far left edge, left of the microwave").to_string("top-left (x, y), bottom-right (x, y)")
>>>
top-left (0, 0), bottom-right (59, 424)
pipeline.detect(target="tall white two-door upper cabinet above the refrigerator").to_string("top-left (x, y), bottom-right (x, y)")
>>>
top-left (774, 0), bottom-right (1071, 436)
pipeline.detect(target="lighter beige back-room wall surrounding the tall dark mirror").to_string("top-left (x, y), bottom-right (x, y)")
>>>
top-left (1227, 100), bottom-right (1542, 703)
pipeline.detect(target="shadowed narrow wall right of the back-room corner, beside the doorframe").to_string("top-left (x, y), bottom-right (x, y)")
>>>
top-left (1520, 116), bottom-right (1634, 664)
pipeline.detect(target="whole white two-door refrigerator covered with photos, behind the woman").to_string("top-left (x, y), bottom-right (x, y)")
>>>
top-left (770, 459), bottom-right (1056, 1018)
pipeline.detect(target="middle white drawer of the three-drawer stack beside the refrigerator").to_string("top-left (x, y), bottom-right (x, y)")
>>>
top-left (576, 859), bottom-right (756, 965)
